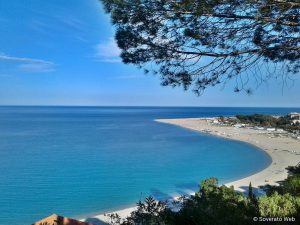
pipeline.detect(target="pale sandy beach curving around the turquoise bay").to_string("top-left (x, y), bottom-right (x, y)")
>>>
top-left (83, 117), bottom-right (300, 224)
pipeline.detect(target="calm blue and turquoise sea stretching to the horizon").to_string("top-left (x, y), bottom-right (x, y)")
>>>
top-left (0, 107), bottom-right (299, 225)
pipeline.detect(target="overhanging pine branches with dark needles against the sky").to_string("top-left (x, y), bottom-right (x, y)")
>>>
top-left (100, 0), bottom-right (300, 94)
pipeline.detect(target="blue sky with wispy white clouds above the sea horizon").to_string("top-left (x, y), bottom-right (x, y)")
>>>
top-left (0, 0), bottom-right (300, 107)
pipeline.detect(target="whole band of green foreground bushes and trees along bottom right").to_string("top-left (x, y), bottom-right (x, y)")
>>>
top-left (111, 165), bottom-right (300, 225)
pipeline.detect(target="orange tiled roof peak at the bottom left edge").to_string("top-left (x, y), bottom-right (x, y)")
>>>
top-left (32, 214), bottom-right (93, 225)
